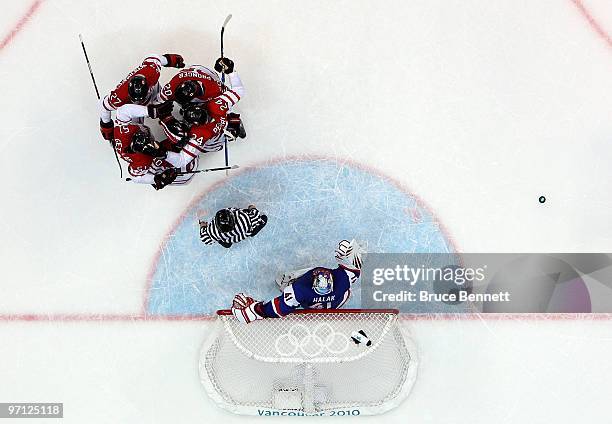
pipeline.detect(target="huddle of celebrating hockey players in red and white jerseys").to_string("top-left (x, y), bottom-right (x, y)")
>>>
top-left (99, 53), bottom-right (246, 190)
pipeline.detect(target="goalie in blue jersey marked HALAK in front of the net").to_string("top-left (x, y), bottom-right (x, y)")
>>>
top-left (232, 240), bottom-right (365, 324)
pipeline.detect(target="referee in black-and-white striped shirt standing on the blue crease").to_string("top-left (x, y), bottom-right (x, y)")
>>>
top-left (200, 205), bottom-right (268, 248)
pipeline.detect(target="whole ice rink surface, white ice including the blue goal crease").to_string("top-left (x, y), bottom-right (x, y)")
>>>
top-left (0, 0), bottom-right (612, 424)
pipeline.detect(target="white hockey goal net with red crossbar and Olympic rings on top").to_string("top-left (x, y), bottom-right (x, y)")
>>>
top-left (200, 309), bottom-right (417, 416)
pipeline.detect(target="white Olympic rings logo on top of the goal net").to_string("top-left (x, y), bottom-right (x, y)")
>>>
top-left (274, 322), bottom-right (350, 358)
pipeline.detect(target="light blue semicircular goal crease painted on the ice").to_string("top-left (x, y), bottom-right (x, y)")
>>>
top-left (145, 158), bottom-right (454, 315)
